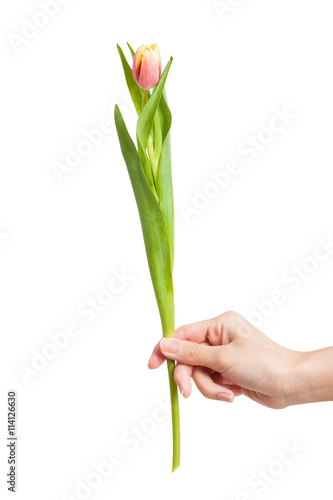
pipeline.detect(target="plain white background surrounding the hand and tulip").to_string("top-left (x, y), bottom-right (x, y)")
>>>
top-left (0, 0), bottom-right (333, 500)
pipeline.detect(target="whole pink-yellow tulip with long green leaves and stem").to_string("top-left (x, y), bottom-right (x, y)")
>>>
top-left (115, 44), bottom-right (180, 471)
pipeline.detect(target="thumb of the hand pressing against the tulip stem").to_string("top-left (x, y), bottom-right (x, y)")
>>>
top-left (160, 337), bottom-right (225, 371)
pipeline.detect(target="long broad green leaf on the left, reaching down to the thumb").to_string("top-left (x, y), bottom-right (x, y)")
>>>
top-left (115, 106), bottom-right (174, 336)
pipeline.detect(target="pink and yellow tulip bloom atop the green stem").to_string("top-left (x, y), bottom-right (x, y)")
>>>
top-left (133, 43), bottom-right (161, 90)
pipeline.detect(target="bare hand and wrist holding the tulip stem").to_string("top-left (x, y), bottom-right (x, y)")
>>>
top-left (148, 312), bottom-right (333, 409)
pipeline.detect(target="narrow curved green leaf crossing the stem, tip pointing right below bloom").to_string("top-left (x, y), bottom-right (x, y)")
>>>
top-left (136, 57), bottom-right (172, 162)
